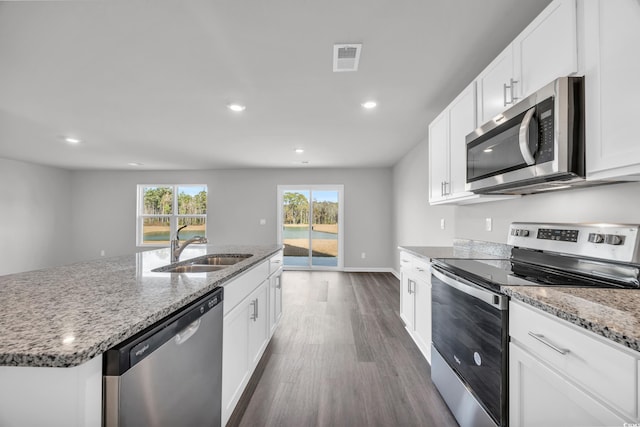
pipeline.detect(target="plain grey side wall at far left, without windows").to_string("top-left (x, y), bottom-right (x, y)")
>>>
top-left (0, 159), bottom-right (73, 275)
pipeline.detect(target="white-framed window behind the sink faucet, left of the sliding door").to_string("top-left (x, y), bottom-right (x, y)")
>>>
top-left (137, 184), bottom-right (207, 246)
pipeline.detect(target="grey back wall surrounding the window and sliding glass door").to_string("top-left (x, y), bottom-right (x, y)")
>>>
top-left (67, 168), bottom-right (395, 268)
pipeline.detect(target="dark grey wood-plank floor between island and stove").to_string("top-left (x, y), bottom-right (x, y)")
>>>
top-left (227, 271), bottom-right (457, 427)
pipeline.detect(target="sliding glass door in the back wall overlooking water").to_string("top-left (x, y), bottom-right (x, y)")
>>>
top-left (278, 185), bottom-right (343, 269)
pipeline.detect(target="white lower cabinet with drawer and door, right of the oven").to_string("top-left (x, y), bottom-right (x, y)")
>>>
top-left (509, 301), bottom-right (640, 427)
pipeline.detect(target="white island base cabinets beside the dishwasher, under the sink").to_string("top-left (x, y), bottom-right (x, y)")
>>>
top-left (222, 252), bottom-right (282, 425)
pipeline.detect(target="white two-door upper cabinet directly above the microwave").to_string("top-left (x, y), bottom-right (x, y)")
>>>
top-left (476, 0), bottom-right (578, 125)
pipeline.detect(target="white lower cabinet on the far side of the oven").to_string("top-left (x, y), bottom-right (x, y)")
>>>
top-left (400, 252), bottom-right (431, 363)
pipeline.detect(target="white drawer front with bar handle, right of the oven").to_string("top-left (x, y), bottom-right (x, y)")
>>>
top-left (509, 301), bottom-right (640, 420)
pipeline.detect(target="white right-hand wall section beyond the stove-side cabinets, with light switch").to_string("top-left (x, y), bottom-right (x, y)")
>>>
top-left (393, 140), bottom-right (455, 271)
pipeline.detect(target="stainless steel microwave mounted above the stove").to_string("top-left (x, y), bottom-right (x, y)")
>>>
top-left (466, 77), bottom-right (584, 194)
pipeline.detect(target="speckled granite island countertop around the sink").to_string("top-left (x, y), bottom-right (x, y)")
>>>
top-left (0, 245), bottom-right (281, 367)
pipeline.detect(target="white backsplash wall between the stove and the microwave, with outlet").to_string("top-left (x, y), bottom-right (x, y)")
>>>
top-left (455, 183), bottom-right (640, 243)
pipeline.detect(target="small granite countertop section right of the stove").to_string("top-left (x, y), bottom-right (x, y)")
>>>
top-left (502, 286), bottom-right (640, 351)
